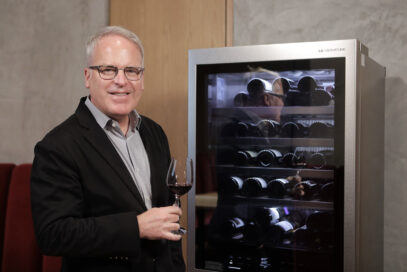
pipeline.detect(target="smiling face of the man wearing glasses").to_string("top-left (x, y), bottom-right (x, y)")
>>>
top-left (85, 35), bottom-right (144, 121)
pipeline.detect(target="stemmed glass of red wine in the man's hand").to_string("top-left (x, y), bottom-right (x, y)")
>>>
top-left (166, 158), bottom-right (194, 235)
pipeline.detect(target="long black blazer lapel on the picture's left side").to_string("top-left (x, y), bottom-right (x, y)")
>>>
top-left (76, 99), bottom-right (147, 210)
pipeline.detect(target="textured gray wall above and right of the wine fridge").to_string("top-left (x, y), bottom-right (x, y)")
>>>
top-left (234, 0), bottom-right (407, 272)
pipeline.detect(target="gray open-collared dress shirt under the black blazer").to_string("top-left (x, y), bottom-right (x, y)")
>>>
top-left (85, 97), bottom-right (152, 209)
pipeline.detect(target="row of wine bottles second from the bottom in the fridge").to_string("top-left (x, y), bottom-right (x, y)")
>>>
top-left (219, 175), bottom-right (334, 201)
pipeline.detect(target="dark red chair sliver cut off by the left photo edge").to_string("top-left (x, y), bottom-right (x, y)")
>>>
top-left (0, 163), bottom-right (16, 271)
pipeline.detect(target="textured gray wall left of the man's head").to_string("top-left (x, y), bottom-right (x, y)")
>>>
top-left (0, 0), bottom-right (109, 163)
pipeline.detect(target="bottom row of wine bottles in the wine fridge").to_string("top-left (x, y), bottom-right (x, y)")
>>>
top-left (211, 207), bottom-right (334, 249)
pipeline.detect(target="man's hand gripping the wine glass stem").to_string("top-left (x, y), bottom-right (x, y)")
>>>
top-left (137, 206), bottom-right (182, 241)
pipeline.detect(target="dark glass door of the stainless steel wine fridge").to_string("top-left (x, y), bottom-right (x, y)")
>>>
top-left (195, 58), bottom-right (345, 272)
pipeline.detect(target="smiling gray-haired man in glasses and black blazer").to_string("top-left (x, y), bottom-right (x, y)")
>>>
top-left (31, 27), bottom-right (185, 272)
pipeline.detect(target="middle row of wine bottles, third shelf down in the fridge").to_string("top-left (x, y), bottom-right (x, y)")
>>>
top-left (233, 147), bottom-right (334, 169)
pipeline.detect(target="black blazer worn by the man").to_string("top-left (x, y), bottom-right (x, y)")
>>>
top-left (31, 97), bottom-right (185, 272)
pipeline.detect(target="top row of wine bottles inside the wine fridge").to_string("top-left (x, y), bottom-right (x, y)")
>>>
top-left (233, 76), bottom-right (334, 107)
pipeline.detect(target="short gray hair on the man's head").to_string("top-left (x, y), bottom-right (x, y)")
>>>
top-left (86, 26), bottom-right (144, 66)
